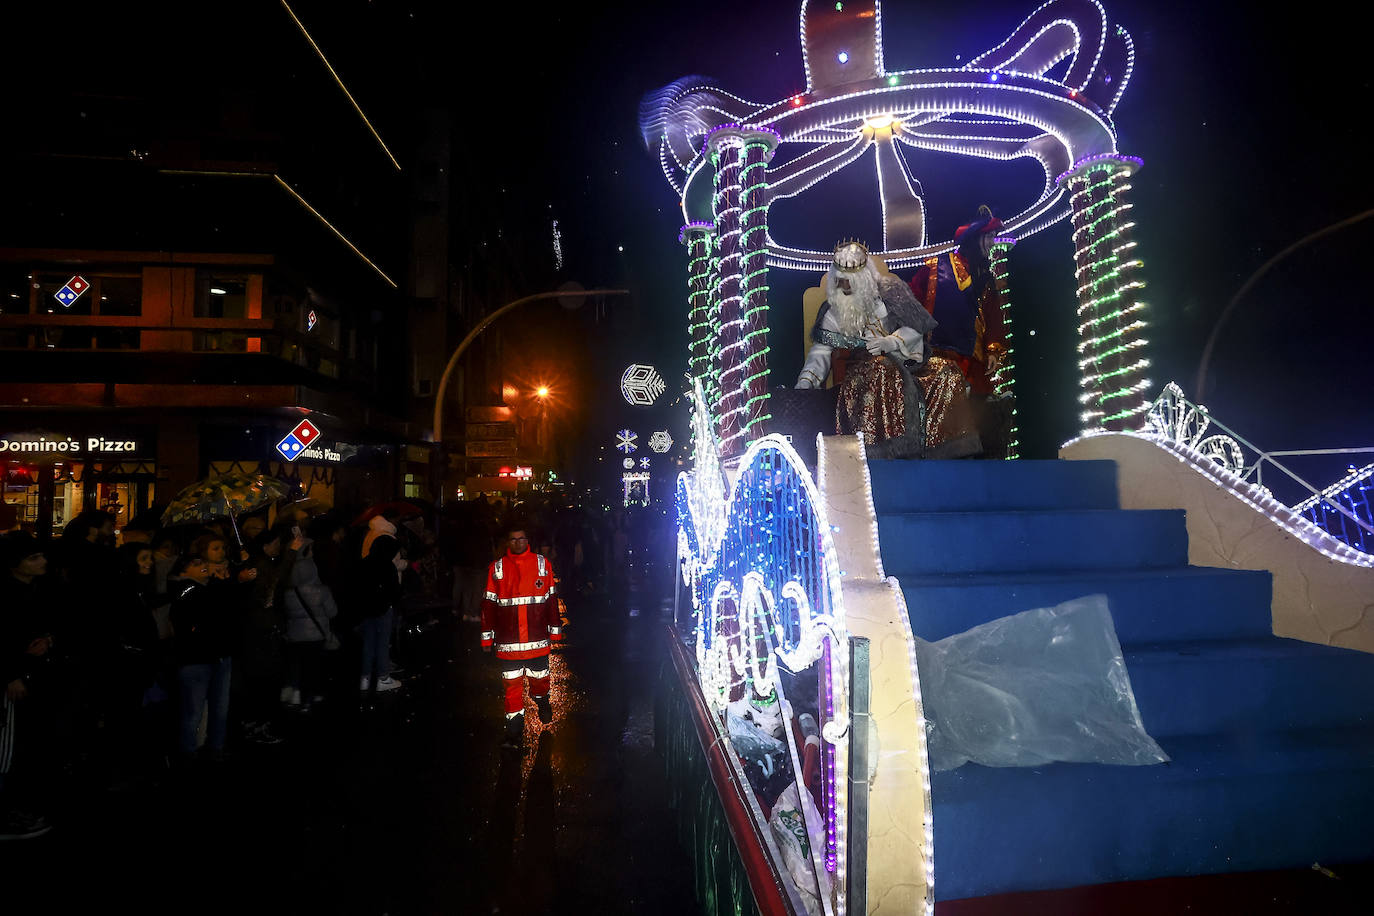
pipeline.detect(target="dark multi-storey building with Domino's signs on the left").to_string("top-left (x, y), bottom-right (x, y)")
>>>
top-left (0, 3), bottom-right (445, 531)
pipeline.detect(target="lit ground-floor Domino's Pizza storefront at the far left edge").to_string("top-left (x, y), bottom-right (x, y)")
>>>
top-left (0, 423), bottom-right (158, 536)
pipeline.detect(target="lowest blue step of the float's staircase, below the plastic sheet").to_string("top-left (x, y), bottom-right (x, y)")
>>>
top-left (932, 726), bottom-right (1374, 900)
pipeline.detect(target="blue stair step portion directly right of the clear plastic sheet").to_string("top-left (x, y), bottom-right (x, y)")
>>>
top-left (1123, 636), bottom-right (1374, 740)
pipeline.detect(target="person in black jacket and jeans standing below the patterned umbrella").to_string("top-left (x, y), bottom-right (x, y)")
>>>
top-left (168, 556), bottom-right (240, 759)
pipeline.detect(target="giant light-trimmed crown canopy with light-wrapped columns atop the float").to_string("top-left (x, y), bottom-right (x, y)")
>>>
top-left (640, 0), bottom-right (1150, 447)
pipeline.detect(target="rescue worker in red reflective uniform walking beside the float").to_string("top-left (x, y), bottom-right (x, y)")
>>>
top-left (482, 525), bottom-right (563, 746)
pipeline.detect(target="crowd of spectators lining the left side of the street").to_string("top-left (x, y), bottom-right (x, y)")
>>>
top-left (0, 497), bottom-right (661, 839)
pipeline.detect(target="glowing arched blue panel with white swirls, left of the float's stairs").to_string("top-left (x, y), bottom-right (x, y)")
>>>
top-left (676, 380), bottom-right (849, 880)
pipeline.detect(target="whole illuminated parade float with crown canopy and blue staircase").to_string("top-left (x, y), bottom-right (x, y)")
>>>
top-left (643, 0), bottom-right (1374, 915)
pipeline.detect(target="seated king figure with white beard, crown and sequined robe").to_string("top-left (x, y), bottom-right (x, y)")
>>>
top-left (797, 242), bottom-right (982, 459)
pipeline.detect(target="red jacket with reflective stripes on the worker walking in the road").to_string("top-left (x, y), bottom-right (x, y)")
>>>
top-left (482, 551), bottom-right (563, 658)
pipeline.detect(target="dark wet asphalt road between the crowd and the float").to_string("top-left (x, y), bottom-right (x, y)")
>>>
top-left (8, 579), bottom-right (694, 916)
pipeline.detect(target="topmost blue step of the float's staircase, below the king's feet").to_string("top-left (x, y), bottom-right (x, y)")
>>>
top-left (868, 460), bottom-right (1118, 514)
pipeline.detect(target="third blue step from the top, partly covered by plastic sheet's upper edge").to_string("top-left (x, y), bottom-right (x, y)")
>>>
top-left (901, 566), bottom-right (1272, 643)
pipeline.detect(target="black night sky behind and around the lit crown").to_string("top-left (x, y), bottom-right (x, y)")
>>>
top-left (5, 0), bottom-right (1374, 502)
